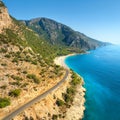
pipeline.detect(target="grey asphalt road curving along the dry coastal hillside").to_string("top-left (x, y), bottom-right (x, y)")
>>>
top-left (2, 70), bottom-right (69, 120)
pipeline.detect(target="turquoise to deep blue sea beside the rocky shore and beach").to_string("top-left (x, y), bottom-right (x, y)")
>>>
top-left (65, 45), bottom-right (120, 120)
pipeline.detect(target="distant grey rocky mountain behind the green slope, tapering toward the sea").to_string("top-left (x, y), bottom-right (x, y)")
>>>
top-left (21, 18), bottom-right (105, 50)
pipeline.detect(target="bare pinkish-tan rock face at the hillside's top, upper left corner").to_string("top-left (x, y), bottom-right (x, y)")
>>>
top-left (0, 1), bottom-right (12, 33)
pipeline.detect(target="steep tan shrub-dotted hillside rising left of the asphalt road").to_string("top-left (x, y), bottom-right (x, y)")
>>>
top-left (0, 2), bottom-right (65, 119)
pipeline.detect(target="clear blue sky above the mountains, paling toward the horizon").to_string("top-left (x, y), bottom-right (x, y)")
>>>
top-left (2, 0), bottom-right (120, 44)
